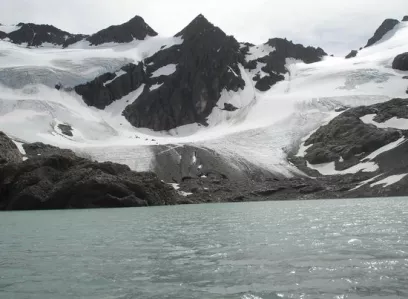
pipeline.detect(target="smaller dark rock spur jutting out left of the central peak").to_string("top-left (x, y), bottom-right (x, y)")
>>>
top-left (75, 63), bottom-right (146, 109)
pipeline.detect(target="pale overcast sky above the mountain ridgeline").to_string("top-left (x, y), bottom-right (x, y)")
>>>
top-left (0, 0), bottom-right (408, 54)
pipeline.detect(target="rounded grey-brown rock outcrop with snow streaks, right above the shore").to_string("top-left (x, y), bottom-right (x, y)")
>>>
top-left (305, 99), bottom-right (408, 167)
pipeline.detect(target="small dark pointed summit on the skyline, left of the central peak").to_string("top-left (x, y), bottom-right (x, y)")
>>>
top-left (87, 16), bottom-right (157, 45)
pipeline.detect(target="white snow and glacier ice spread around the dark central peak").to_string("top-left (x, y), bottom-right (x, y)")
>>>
top-left (0, 22), bottom-right (408, 178)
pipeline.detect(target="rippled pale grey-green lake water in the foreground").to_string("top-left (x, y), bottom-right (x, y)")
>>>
top-left (0, 198), bottom-right (408, 299)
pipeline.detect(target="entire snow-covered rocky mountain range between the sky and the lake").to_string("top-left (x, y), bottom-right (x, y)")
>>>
top-left (0, 15), bottom-right (408, 209)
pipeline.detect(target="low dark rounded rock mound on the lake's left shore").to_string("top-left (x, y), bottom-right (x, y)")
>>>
top-left (0, 147), bottom-right (176, 210)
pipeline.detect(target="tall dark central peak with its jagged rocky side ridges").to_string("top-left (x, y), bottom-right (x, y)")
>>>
top-left (75, 15), bottom-right (327, 131)
